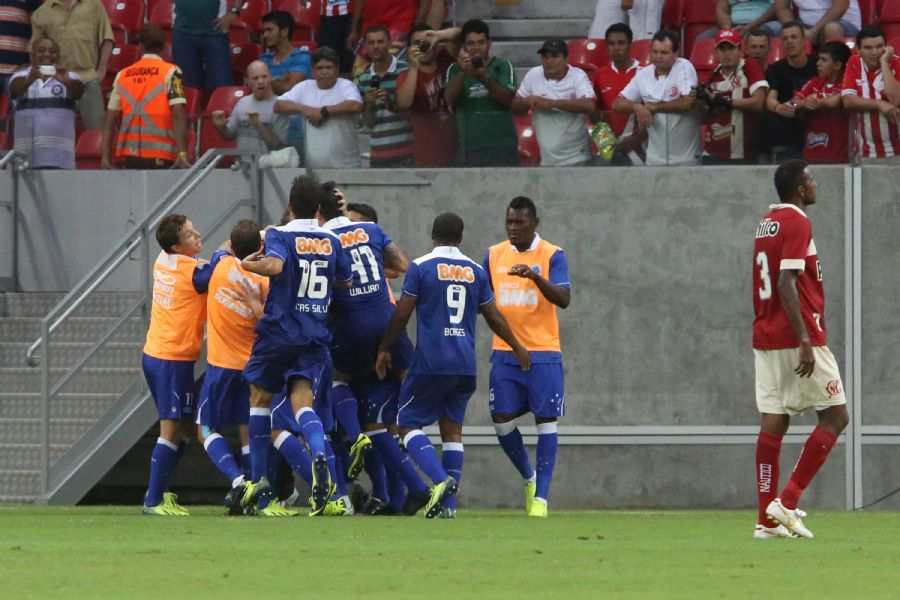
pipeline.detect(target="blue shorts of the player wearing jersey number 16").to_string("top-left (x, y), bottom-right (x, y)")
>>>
top-left (244, 337), bottom-right (331, 394)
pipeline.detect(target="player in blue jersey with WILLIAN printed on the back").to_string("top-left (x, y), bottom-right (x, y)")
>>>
top-left (320, 189), bottom-right (428, 514)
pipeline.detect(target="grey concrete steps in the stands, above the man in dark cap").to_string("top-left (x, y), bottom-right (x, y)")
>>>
top-left (456, 0), bottom-right (596, 82)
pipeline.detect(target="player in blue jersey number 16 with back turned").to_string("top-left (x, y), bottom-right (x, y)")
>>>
top-left (240, 176), bottom-right (352, 515)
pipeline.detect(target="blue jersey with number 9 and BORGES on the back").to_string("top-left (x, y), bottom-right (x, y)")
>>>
top-left (403, 246), bottom-right (494, 375)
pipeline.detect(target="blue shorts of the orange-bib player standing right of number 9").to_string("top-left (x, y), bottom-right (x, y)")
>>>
top-left (490, 363), bottom-right (566, 418)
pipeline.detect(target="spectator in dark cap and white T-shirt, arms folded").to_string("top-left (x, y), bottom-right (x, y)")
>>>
top-left (512, 39), bottom-right (597, 167)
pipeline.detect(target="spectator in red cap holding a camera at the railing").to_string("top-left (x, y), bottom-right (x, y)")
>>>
top-left (697, 29), bottom-right (769, 165)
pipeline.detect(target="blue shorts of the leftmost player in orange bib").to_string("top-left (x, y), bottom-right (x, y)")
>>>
top-left (141, 354), bottom-right (197, 421)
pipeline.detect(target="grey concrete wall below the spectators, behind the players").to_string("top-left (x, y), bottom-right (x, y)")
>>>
top-left (0, 167), bottom-right (900, 507)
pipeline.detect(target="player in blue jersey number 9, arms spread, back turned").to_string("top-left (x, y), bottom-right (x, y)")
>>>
top-left (376, 213), bottom-right (531, 519)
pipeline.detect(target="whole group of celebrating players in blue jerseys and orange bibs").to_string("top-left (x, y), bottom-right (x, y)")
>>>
top-left (137, 176), bottom-right (570, 518)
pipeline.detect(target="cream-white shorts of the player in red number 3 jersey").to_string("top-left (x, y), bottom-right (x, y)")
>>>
top-left (753, 346), bottom-right (847, 415)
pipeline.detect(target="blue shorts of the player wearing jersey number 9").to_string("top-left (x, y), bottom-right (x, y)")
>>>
top-left (397, 375), bottom-right (475, 429)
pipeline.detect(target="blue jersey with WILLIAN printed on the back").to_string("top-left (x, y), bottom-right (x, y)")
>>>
top-left (323, 217), bottom-right (391, 312)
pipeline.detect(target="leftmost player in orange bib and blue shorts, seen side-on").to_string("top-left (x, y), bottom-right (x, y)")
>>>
top-left (142, 214), bottom-right (219, 516)
